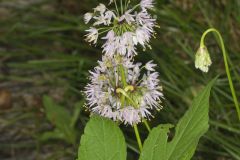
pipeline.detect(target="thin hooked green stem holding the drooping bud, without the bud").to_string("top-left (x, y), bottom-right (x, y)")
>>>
top-left (200, 28), bottom-right (240, 120)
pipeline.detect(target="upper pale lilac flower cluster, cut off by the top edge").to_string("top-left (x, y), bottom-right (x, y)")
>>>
top-left (84, 0), bottom-right (157, 57)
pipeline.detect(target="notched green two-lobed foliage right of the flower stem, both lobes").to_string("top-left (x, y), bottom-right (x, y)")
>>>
top-left (140, 79), bottom-right (215, 160)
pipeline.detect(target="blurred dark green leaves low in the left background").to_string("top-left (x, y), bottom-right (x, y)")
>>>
top-left (41, 96), bottom-right (77, 144)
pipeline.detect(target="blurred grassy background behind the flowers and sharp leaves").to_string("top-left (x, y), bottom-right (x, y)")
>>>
top-left (0, 0), bottom-right (240, 160)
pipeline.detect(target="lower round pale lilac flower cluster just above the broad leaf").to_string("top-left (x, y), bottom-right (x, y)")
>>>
top-left (84, 56), bottom-right (163, 125)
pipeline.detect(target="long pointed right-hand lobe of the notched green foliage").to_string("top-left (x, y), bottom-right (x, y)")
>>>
top-left (167, 79), bottom-right (215, 160)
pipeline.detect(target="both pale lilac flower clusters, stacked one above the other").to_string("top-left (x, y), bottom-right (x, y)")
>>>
top-left (84, 0), bottom-right (163, 125)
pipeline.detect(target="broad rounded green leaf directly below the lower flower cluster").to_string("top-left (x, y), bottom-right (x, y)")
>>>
top-left (78, 116), bottom-right (127, 160)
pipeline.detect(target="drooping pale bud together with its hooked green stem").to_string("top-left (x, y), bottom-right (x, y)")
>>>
top-left (195, 28), bottom-right (240, 120)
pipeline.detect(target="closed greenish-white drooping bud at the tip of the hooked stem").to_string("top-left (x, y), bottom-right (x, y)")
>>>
top-left (195, 46), bottom-right (212, 72)
